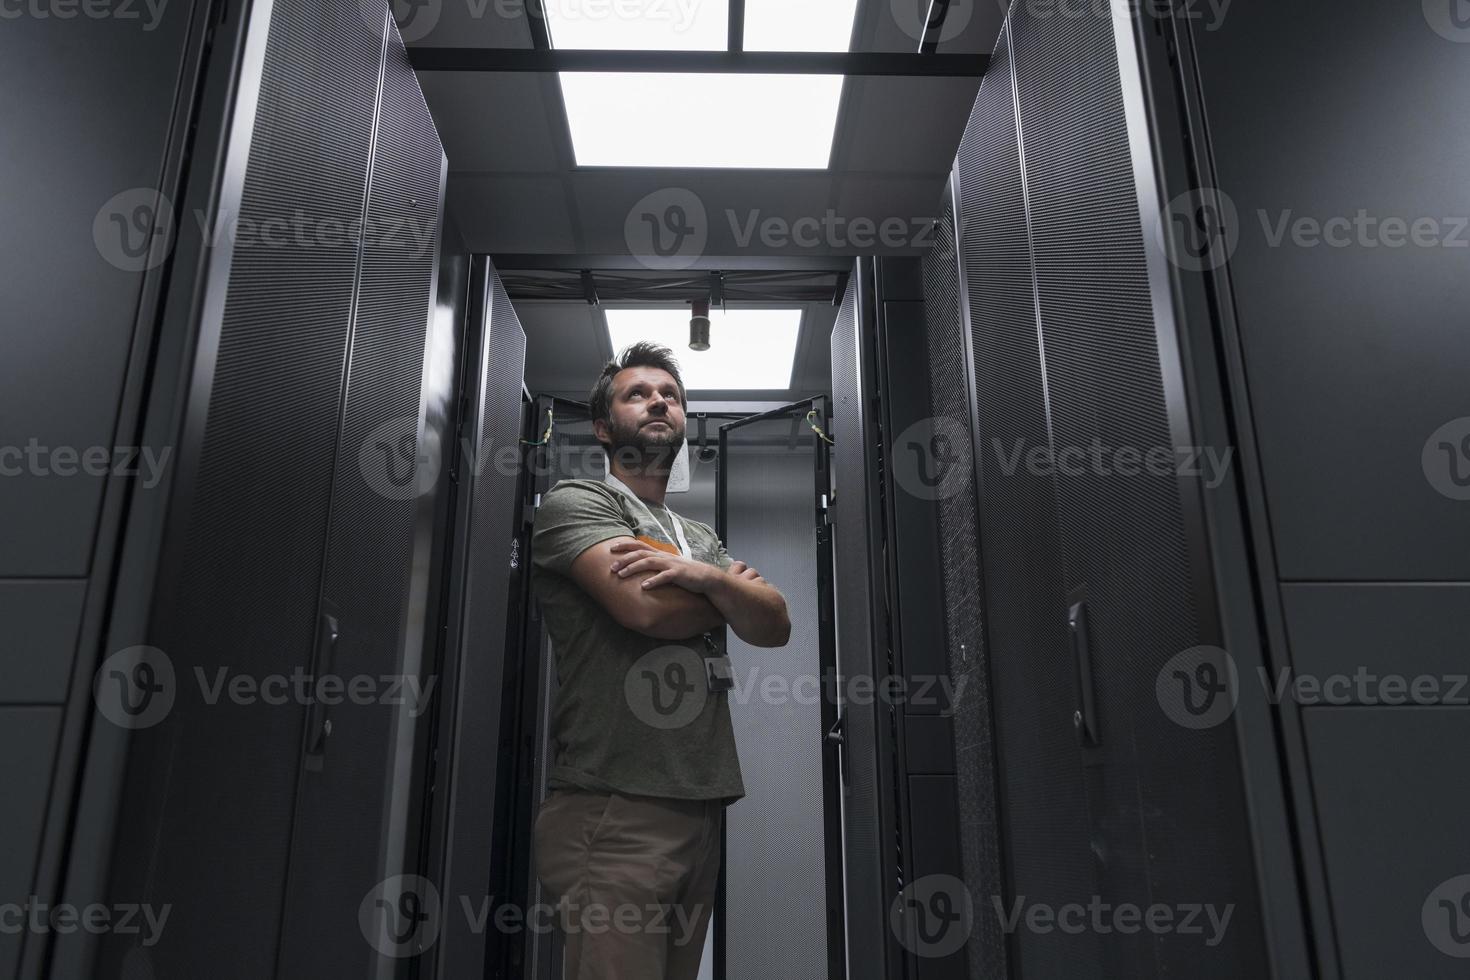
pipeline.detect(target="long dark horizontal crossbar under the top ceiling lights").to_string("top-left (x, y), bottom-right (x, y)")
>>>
top-left (409, 47), bottom-right (991, 78)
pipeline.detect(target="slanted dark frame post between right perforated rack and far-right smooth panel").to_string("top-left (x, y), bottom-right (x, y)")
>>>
top-left (1114, 3), bottom-right (1323, 980)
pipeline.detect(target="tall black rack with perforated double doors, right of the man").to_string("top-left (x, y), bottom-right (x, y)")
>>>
top-left (905, 4), bottom-right (1304, 977)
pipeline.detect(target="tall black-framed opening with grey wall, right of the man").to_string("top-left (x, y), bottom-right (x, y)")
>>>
top-left (714, 397), bottom-right (847, 980)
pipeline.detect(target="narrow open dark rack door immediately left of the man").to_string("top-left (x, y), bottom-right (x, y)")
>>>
top-left (423, 256), bottom-right (529, 980)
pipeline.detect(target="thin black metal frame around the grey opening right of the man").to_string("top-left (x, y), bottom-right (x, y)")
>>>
top-left (714, 395), bottom-right (847, 980)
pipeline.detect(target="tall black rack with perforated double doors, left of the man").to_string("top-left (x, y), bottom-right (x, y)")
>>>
top-left (47, 0), bottom-right (445, 976)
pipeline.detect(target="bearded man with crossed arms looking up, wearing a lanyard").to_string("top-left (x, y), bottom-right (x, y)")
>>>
top-left (532, 344), bottom-right (791, 980)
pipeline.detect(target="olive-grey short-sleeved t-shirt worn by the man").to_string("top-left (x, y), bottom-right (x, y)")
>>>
top-left (531, 480), bottom-right (745, 804)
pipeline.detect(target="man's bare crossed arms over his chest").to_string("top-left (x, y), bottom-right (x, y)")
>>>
top-left (572, 536), bottom-right (791, 646)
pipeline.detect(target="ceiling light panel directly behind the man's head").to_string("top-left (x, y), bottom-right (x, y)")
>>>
top-left (604, 307), bottom-right (801, 391)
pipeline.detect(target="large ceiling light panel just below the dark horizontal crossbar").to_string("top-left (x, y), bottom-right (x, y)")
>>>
top-left (562, 72), bottom-right (842, 170)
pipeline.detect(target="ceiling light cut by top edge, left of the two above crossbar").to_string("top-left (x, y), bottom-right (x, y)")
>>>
top-left (542, 0), bottom-right (731, 51)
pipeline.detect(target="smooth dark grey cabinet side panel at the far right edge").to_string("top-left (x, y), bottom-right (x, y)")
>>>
top-left (1130, 3), bottom-right (1470, 977)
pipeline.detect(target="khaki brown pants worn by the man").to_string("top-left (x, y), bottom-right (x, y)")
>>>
top-left (535, 790), bottom-right (725, 980)
